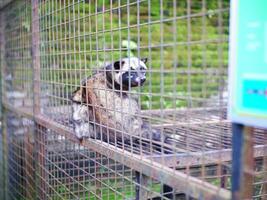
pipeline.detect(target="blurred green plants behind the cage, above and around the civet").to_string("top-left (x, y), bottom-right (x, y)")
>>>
top-left (36, 0), bottom-right (229, 109)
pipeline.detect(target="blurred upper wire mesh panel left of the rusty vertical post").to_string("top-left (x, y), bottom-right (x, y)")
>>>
top-left (2, 1), bottom-right (33, 112)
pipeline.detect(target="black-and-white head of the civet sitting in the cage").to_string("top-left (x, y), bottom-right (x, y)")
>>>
top-left (106, 57), bottom-right (147, 90)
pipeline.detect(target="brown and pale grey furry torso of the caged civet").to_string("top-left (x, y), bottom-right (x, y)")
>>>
top-left (77, 73), bottom-right (142, 142)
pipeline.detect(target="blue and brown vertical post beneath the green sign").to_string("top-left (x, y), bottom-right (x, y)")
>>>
top-left (232, 123), bottom-right (254, 200)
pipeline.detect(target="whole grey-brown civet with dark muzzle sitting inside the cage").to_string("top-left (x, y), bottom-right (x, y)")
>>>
top-left (72, 57), bottom-right (174, 151)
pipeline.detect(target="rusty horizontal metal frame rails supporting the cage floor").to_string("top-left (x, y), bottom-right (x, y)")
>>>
top-left (3, 95), bottom-right (266, 199)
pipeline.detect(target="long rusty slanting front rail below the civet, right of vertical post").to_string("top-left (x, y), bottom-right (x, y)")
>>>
top-left (36, 113), bottom-right (230, 199)
